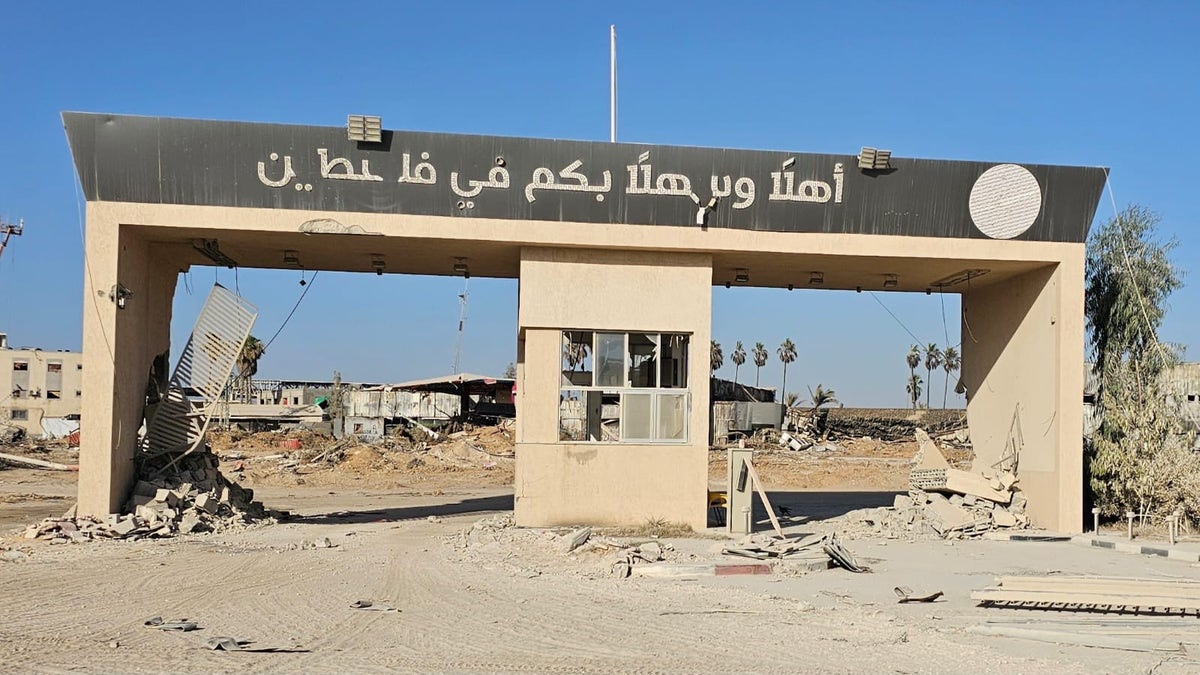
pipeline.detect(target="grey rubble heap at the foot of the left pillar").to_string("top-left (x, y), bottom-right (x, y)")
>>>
top-left (24, 452), bottom-right (278, 544)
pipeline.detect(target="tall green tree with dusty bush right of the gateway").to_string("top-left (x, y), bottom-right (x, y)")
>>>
top-left (1085, 205), bottom-right (1200, 520)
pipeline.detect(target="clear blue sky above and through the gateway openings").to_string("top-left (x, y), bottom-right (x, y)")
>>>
top-left (0, 1), bottom-right (1200, 406)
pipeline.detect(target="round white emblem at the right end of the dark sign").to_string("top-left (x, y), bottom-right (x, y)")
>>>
top-left (968, 165), bottom-right (1042, 239)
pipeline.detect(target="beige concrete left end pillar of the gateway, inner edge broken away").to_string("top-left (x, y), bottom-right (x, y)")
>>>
top-left (79, 210), bottom-right (179, 516)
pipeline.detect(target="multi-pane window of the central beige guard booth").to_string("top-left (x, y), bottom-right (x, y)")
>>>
top-left (558, 330), bottom-right (690, 443)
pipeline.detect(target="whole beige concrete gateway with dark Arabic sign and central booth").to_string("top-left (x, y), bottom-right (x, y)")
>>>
top-left (64, 113), bottom-right (1105, 531)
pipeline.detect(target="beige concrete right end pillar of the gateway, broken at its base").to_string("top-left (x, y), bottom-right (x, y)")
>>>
top-left (962, 246), bottom-right (1084, 532)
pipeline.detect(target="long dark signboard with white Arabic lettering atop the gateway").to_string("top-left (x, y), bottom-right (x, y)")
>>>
top-left (62, 113), bottom-right (1106, 241)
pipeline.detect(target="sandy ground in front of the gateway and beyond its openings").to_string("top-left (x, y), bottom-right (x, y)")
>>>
top-left (7, 429), bottom-right (1200, 674)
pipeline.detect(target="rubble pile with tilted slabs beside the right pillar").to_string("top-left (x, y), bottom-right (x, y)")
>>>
top-left (842, 429), bottom-right (1030, 539)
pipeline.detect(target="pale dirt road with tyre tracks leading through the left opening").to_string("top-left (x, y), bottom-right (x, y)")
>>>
top-left (0, 486), bottom-right (1194, 674)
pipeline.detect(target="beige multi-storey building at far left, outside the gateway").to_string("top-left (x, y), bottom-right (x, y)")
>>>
top-left (0, 333), bottom-right (83, 438)
